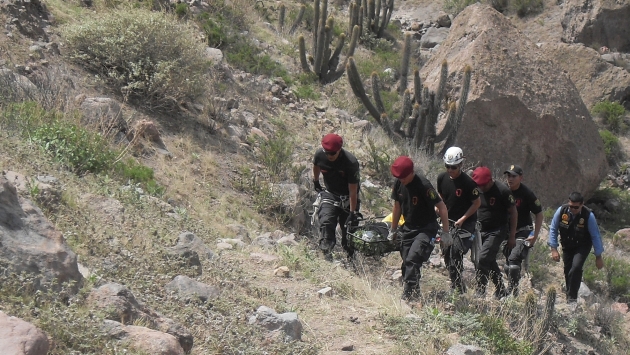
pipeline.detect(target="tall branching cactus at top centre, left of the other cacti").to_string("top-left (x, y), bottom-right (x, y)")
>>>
top-left (298, 0), bottom-right (360, 84)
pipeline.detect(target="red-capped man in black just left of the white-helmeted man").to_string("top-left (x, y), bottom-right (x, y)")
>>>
top-left (388, 156), bottom-right (448, 300)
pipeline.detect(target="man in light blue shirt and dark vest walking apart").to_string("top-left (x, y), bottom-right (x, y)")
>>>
top-left (547, 192), bottom-right (604, 303)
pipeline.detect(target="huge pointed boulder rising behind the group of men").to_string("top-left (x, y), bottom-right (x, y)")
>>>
top-left (420, 3), bottom-right (607, 206)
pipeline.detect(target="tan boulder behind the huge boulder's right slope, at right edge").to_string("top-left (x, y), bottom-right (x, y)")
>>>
top-left (540, 43), bottom-right (630, 109)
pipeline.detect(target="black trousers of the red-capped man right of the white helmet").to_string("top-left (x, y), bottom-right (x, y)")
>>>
top-left (476, 225), bottom-right (508, 296)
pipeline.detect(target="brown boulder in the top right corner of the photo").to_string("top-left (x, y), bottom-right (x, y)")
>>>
top-left (562, 0), bottom-right (630, 52)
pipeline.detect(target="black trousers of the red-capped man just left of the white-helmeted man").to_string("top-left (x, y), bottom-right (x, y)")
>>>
top-left (399, 222), bottom-right (438, 292)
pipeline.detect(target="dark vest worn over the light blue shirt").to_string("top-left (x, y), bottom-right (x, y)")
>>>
top-left (558, 204), bottom-right (592, 249)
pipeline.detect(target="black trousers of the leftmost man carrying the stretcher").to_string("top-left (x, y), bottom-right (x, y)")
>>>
top-left (317, 191), bottom-right (359, 256)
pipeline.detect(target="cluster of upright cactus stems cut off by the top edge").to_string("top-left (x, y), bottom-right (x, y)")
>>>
top-left (348, 0), bottom-right (394, 39)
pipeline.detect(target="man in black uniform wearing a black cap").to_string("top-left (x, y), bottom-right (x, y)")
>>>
top-left (503, 165), bottom-right (543, 296)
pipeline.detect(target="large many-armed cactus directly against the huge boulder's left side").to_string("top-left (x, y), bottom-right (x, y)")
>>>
top-left (347, 52), bottom-right (472, 154)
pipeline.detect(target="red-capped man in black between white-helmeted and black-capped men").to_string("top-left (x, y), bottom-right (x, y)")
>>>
top-left (472, 166), bottom-right (518, 299)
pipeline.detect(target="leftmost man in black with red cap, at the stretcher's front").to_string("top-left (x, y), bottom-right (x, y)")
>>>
top-left (313, 133), bottom-right (360, 258)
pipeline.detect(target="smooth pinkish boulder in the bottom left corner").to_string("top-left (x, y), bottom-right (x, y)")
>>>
top-left (0, 311), bottom-right (49, 355)
